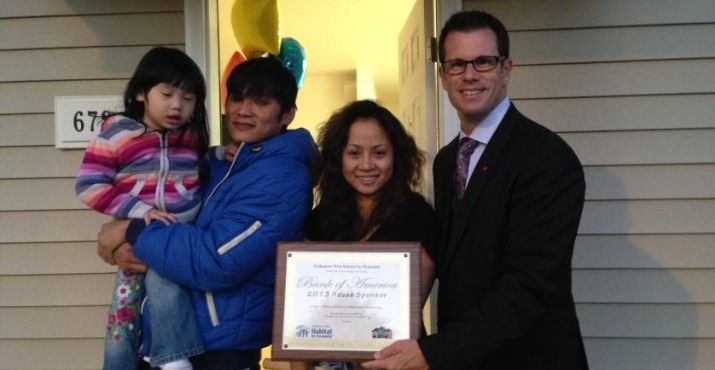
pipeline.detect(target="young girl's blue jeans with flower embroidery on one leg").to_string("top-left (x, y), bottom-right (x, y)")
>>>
top-left (104, 269), bottom-right (204, 370)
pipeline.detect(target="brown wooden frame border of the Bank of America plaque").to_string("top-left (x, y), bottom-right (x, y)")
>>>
top-left (271, 242), bottom-right (422, 361)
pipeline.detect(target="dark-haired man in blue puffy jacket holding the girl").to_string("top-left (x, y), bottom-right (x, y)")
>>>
top-left (98, 58), bottom-right (315, 370)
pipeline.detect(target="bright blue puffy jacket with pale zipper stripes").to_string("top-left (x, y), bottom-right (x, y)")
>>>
top-left (134, 129), bottom-right (316, 351)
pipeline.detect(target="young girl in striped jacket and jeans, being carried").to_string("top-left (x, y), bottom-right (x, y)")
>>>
top-left (75, 47), bottom-right (209, 370)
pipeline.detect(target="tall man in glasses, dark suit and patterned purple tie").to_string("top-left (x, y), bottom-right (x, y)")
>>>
top-left (364, 11), bottom-right (588, 370)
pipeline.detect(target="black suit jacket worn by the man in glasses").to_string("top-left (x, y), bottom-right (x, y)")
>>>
top-left (419, 105), bottom-right (588, 370)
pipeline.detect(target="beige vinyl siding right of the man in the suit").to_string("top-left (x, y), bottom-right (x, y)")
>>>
top-left (463, 0), bottom-right (715, 370)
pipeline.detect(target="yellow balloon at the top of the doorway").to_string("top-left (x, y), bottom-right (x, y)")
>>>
top-left (231, 0), bottom-right (280, 59)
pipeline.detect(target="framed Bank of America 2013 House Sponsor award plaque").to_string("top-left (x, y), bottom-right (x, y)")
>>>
top-left (271, 242), bottom-right (421, 360)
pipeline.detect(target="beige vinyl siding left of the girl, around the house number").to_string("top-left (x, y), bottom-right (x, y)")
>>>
top-left (0, 0), bottom-right (184, 370)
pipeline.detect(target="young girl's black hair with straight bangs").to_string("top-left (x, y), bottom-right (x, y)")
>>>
top-left (123, 47), bottom-right (209, 160)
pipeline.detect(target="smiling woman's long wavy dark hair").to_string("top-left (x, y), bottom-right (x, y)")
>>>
top-left (316, 100), bottom-right (425, 240)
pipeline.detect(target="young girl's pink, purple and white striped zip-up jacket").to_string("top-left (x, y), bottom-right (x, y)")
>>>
top-left (75, 116), bottom-right (201, 222)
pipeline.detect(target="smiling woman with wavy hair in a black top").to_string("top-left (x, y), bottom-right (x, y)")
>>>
top-left (305, 100), bottom-right (438, 303)
